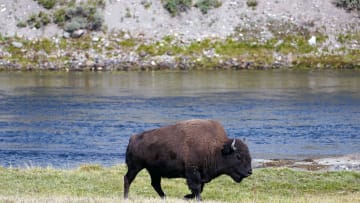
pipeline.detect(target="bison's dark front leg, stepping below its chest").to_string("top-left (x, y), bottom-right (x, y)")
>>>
top-left (184, 168), bottom-right (204, 201)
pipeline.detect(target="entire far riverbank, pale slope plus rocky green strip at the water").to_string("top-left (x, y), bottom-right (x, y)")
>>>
top-left (0, 0), bottom-right (360, 71)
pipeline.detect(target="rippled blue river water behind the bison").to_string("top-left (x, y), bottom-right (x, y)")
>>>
top-left (0, 71), bottom-right (360, 168)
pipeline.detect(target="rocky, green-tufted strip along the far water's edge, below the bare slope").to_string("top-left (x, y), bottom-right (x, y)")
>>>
top-left (0, 30), bottom-right (360, 71)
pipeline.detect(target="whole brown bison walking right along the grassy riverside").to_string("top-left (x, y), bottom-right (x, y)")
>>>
top-left (124, 120), bottom-right (252, 200)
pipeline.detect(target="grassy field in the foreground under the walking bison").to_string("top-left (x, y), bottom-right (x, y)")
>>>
top-left (0, 165), bottom-right (360, 203)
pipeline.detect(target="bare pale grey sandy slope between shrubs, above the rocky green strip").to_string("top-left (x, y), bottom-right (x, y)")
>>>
top-left (0, 0), bottom-right (360, 39)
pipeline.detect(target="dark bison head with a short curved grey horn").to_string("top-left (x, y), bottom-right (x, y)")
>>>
top-left (221, 139), bottom-right (252, 183)
